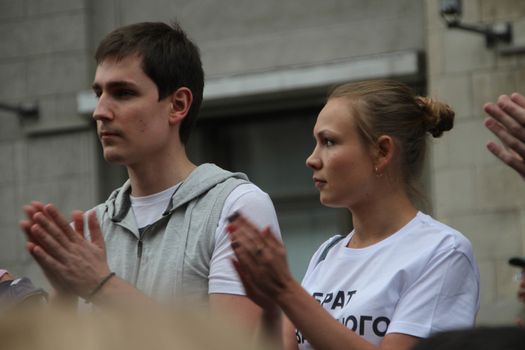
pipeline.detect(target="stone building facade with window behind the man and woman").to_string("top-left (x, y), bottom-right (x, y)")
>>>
top-left (0, 0), bottom-right (525, 324)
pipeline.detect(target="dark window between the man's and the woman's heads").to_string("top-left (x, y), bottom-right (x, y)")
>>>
top-left (188, 105), bottom-right (351, 280)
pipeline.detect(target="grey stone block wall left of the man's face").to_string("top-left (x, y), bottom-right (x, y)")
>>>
top-left (0, 0), bottom-right (97, 283)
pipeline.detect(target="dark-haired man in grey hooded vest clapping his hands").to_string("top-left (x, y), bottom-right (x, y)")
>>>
top-left (21, 23), bottom-right (279, 324)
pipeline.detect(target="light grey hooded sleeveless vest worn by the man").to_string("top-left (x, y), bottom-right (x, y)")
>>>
top-left (96, 164), bottom-right (248, 302)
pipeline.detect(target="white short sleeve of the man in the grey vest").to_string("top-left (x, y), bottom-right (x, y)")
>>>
top-left (208, 183), bottom-right (281, 295)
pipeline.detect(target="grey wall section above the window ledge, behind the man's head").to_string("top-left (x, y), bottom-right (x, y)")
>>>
top-left (93, 0), bottom-right (424, 78)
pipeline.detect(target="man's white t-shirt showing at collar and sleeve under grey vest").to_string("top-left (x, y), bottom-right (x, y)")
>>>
top-left (130, 183), bottom-right (281, 295)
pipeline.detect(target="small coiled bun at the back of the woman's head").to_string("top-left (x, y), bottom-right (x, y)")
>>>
top-left (416, 96), bottom-right (455, 137)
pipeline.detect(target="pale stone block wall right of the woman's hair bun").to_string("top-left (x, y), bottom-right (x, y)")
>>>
top-left (426, 0), bottom-right (525, 324)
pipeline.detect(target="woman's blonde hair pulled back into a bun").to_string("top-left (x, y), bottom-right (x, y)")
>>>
top-left (328, 80), bottom-right (454, 195)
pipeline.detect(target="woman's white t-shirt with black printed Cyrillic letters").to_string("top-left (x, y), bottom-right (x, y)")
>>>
top-left (297, 213), bottom-right (479, 349)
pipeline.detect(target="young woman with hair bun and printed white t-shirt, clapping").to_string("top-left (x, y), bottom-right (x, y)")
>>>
top-left (229, 81), bottom-right (479, 350)
